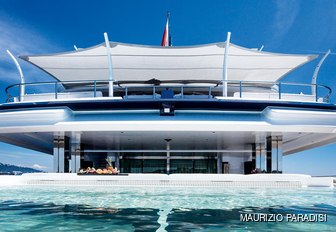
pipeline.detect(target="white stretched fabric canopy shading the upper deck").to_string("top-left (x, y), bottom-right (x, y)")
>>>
top-left (20, 42), bottom-right (316, 82)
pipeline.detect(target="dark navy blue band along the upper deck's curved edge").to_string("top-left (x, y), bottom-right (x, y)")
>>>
top-left (0, 97), bottom-right (336, 112)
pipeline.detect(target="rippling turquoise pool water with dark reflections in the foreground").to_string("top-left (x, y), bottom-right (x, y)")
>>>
top-left (0, 186), bottom-right (336, 231)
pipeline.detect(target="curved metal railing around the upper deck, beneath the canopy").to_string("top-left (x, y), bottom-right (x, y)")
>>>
top-left (6, 80), bottom-right (331, 103)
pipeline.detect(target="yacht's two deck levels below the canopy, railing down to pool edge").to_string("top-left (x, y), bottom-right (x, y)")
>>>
top-left (0, 82), bottom-right (336, 174)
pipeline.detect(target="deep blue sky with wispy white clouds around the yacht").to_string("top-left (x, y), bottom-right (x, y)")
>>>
top-left (0, 0), bottom-right (336, 175)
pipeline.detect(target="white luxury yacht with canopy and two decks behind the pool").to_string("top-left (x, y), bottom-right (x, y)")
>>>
top-left (0, 35), bottom-right (336, 182)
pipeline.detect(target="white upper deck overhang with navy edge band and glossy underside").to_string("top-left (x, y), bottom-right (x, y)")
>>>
top-left (0, 99), bottom-right (336, 154)
